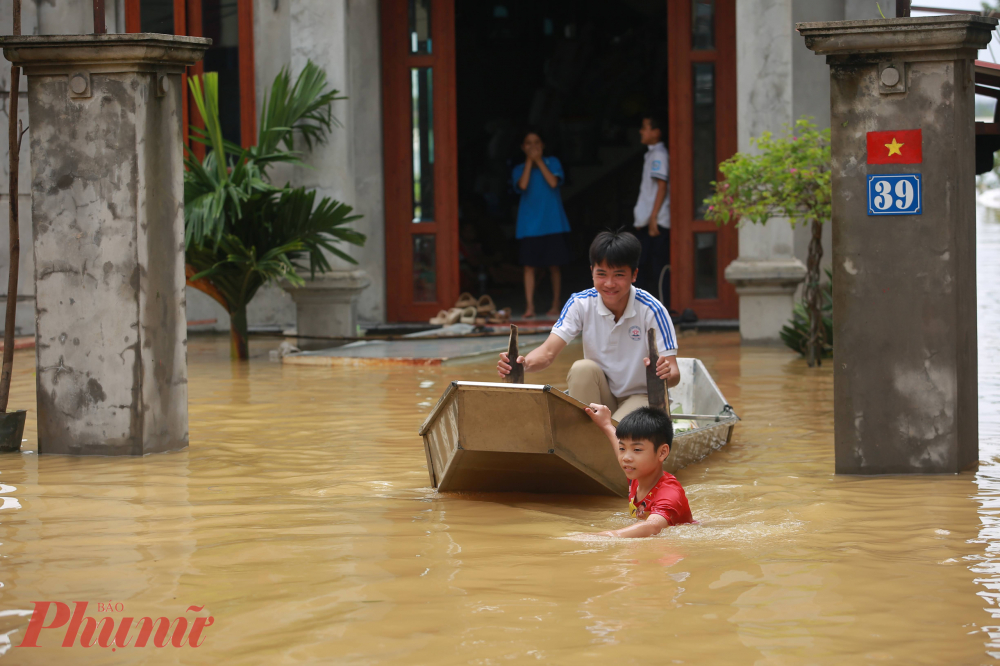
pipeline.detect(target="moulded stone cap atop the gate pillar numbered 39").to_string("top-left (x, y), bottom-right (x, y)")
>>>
top-left (795, 15), bottom-right (998, 60)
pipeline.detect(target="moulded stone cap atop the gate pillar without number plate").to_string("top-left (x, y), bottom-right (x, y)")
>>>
top-left (0, 32), bottom-right (212, 74)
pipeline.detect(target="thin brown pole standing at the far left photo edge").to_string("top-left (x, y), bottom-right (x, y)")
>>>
top-left (0, 0), bottom-right (21, 412)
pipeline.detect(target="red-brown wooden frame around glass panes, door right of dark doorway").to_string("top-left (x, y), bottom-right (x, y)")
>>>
top-left (667, 0), bottom-right (739, 319)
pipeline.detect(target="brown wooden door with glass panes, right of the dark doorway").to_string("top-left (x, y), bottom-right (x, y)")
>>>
top-left (667, 0), bottom-right (739, 319)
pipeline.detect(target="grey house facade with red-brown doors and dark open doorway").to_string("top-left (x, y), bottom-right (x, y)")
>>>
top-left (0, 0), bottom-right (895, 342)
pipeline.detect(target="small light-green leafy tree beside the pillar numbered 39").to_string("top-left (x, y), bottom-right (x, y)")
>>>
top-left (705, 118), bottom-right (832, 367)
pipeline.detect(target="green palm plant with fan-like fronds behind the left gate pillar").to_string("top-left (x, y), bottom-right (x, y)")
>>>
top-left (184, 62), bottom-right (365, 359)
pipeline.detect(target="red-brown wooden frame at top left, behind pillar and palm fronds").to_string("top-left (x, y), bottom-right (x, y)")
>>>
top-left (125, 0), bottom-right (257, 150)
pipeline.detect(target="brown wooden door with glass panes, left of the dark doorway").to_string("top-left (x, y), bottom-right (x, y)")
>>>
top-left (382, 0), bottom-right (459, 321)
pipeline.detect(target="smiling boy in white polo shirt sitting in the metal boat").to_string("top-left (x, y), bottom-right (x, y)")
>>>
top-left (497, 230), bottom-right (681, 421)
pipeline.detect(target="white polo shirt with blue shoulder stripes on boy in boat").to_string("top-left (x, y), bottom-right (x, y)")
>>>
top-left (552, 286), bottom-right (677, 398)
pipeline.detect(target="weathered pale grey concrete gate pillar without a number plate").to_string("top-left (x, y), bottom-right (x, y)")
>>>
top-left (0, 34), bottom-right (211, 455)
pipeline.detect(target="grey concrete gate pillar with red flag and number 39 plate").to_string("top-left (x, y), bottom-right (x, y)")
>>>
top-left (796, 16), bottom-right (997, 474)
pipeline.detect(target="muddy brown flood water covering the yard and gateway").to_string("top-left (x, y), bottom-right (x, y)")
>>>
top-left (0, 212), bottom-right (1000, 665)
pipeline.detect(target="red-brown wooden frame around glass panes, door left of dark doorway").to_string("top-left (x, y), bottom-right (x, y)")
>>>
top-left (381, 0), bottom-right (459, 321)
